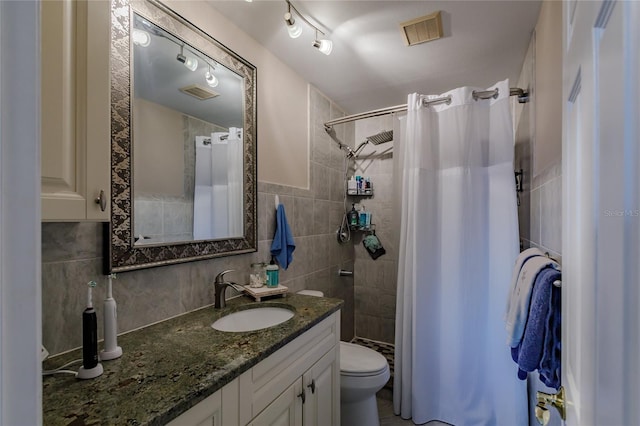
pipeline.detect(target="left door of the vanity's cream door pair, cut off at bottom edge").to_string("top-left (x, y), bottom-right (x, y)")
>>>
top-left (249, 378), bottom-right (309, 426)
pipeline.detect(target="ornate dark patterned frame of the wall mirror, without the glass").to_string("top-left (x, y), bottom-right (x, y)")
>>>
top-left (106, 0), bottom-right (258, 272)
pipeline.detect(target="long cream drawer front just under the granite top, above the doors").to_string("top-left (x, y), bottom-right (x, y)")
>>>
top-left (241, 312), bottom-right (340, 417)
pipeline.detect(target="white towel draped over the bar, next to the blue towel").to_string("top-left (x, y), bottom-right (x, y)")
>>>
top-left (506, 256), bottom-right (560, 348)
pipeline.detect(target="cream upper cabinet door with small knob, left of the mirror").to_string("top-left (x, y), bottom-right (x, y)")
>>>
top-left (40, 0), bottom-right (110, 221)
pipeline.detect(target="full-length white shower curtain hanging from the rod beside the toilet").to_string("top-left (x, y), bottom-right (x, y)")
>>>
top-left (393, 81), bottom-right (528, 426)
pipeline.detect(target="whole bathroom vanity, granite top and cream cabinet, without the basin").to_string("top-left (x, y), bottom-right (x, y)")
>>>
top-left (43, 295), bottom-right (343, 426)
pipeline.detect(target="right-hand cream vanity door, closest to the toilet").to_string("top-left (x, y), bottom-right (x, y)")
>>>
top-left (302, 346), bottom-right (340, 426)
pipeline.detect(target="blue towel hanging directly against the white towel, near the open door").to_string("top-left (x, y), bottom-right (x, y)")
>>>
top-left (512, 267), bottom-right (560, 380)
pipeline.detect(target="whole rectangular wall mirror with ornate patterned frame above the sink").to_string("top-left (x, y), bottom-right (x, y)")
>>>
top-left (107, 0), bottom-right (257, 272)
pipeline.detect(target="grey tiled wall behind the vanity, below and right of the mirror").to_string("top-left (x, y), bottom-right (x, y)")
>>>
top-left (42, 88), bottom-right (355, 354)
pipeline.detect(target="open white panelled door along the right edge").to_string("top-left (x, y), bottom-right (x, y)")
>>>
top-left (562, 0), bottom-right (640, 426)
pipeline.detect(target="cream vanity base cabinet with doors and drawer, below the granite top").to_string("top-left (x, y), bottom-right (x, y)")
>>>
top-left (169, 311), bottom-right (340, 426)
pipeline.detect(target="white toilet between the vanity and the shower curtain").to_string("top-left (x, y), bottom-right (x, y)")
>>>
top-left (298, 290), bottom-right (391, 426)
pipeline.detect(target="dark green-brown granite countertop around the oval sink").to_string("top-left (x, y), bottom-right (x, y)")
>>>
top-left (42, 294), bottom-right (343, 425)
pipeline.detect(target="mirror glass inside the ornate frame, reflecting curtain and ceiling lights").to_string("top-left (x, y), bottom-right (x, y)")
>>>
top-left (131, 13), bottom-right (245, 246)
